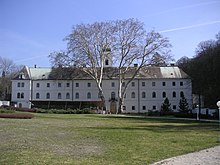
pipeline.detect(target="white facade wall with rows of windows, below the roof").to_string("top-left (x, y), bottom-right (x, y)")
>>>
top-left (12, 75), bottom-right (192, 113)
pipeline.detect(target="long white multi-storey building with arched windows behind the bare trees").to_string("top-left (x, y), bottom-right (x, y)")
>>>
top-left (11, 62), bottom-right (192, 113)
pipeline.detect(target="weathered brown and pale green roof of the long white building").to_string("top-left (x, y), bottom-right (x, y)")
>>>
top-left (14, 66), bottom-right (189, 80)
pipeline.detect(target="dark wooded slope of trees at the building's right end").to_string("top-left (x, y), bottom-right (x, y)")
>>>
top-left (177, 32), bottom-right (220, 108)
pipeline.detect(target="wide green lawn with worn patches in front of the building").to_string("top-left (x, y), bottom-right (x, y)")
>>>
top-left (0, 114), bottom-right (219, 165)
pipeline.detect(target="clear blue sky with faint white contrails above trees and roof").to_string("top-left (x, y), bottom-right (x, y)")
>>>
top-left (0, 0), bottom-right (220, 67)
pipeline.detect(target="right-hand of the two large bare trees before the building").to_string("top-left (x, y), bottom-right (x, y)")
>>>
top-left (113, 19), bottom-right (171, 113)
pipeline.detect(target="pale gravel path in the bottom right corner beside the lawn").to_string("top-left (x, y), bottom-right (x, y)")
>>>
top-left (152, 146), bottom-right (220, 165)
